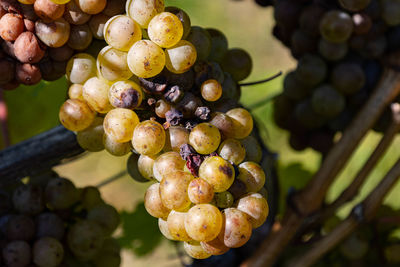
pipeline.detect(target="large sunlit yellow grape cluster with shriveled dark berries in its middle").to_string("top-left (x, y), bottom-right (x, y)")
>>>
top-left (59, 0), bottom-right (269, 259)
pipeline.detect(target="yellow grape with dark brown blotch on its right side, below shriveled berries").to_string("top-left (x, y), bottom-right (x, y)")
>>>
top-left (199, 156), bottom-right (235, 193)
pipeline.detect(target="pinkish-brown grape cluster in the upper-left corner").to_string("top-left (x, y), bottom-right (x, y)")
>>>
top-left (0, 0), bottom-right (125, 90)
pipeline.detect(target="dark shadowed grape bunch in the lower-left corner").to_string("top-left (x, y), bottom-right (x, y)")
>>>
top-left (0, 171), bottom-right (121, 267)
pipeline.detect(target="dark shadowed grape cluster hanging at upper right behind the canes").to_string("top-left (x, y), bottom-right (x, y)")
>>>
top-left (273, 0), bottom-right (400, 153)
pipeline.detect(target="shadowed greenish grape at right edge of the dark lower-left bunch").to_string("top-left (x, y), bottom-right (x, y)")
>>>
top-left (86, 203), bottom-right (120, 235)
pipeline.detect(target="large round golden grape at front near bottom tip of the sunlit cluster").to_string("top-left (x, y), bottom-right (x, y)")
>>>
top-left (185, 204), bottom-right (222, 242)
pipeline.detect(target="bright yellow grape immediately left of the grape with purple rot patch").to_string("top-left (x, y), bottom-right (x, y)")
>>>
top-left (82, 77), bottom-right (113, 114)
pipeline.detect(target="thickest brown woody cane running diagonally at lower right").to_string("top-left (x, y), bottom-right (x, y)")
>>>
top-left (242, 52), bottom-right (400, 267)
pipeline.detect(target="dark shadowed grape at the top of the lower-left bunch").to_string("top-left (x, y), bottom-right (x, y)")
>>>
top-left (45, 178), bottom-right (79, 210)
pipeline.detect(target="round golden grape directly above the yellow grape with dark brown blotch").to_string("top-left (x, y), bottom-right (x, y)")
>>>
top-left (189, 122), bottom-right (221, 155)
